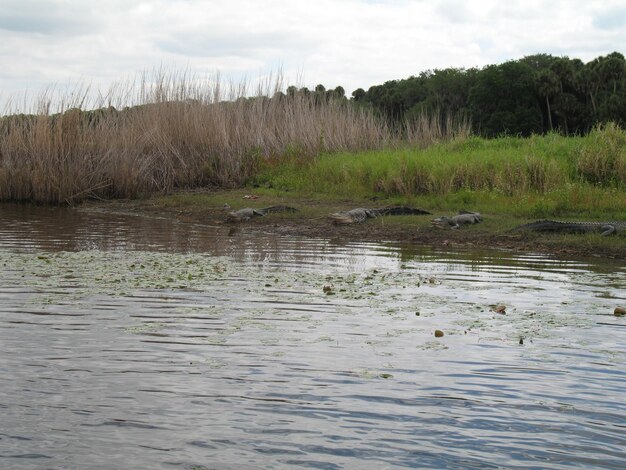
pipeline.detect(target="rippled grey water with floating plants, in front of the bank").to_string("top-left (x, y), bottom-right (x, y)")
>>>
top-left (0, 205), bottom-right (626, 469)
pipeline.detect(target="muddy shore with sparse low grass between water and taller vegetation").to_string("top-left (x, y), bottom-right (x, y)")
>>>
top-left (76, 190), bottom-right (626, 260)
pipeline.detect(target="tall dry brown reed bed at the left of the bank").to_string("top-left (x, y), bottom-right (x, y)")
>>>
top-left (0, 73), bottom-right (392, 203)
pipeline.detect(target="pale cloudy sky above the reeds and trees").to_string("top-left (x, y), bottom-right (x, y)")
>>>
top-left (0, 0), bottom-right (626, 107)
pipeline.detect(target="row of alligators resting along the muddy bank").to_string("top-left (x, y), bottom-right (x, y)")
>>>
top-left (224, 204), bottom-right (626, 235)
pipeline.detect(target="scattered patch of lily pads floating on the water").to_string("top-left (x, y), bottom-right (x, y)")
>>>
top-left (0, 246), bottom-right (616, 352)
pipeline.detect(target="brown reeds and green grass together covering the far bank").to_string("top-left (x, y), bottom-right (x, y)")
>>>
top-left (0, 70), bottom-right (626, 253)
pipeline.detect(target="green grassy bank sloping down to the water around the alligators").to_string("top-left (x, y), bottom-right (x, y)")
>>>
top-left (95, 126), bottom-right (626, 259)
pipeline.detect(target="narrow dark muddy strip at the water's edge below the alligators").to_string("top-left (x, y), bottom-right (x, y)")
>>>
top-left (78, 195), bottom-right (626, 260)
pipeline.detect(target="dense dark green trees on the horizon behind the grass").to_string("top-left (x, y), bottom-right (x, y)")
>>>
top-left (352, 52), bottom-right (626, 137)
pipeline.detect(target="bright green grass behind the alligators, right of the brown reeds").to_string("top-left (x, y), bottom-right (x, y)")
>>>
top-left (251, 125), bottom-right (626, 220)
